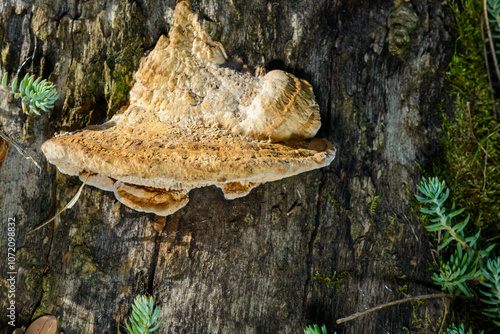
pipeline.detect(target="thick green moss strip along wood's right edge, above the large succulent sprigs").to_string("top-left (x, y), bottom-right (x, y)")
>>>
top-left (434, 0), bottom-right (500, 238)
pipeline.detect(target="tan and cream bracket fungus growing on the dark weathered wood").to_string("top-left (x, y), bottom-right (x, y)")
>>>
top-left (42, 1), bottom-right (335, 216)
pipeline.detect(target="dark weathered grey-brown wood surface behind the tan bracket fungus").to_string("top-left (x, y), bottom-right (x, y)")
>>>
top-left (0, 0), bottom-right (453, 334)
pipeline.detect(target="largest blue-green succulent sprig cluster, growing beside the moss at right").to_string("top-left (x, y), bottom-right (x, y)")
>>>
top-left (415, 178), bottom-right (500, 326)
